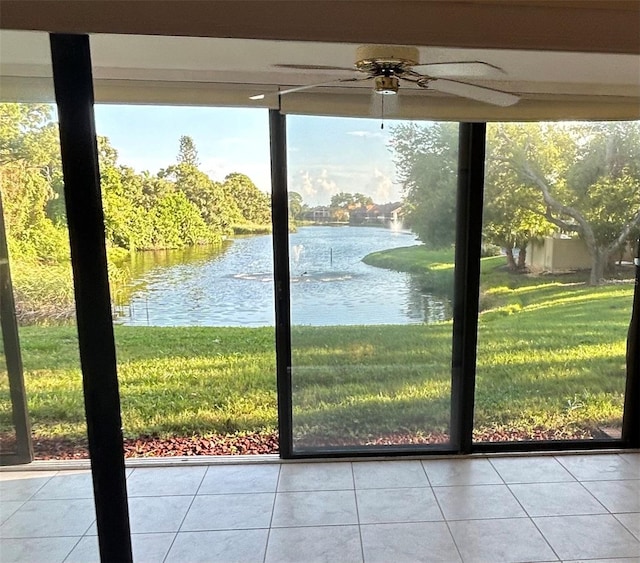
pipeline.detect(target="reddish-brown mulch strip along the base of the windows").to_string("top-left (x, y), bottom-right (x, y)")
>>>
top-left (0, 429), bottom-right (593, 460)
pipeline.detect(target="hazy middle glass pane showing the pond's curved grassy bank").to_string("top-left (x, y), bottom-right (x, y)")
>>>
top-left (287, 116), bottom-right (458, 451)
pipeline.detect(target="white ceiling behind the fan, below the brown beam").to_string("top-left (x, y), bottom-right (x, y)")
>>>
top-left (0, 30), bottom-right (640, 119)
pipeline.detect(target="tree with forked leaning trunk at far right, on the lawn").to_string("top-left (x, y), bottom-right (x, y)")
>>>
top-left (501, 122), bottom-right (640, 285)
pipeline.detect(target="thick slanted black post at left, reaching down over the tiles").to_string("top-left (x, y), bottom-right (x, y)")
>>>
top-left (50, 33), bottom-right (132, 562)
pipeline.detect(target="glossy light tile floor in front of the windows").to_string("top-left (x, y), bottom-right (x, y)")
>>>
top-left (0, 453), bottom-right (640, 563)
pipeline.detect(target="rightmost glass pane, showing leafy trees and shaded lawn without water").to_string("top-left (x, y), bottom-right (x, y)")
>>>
top-left (474, 122), bottom-right (640, 441)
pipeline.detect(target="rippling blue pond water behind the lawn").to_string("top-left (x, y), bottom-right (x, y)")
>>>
top-left (116, 226), bottom-right (450, 327)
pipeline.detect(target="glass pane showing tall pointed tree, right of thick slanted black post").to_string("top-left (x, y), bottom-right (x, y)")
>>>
top-left (91, 103), bottom-right (278, 457)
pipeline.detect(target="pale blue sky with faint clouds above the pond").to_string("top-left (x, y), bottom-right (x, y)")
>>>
top-left (95, 104), bottom-right (402, 206)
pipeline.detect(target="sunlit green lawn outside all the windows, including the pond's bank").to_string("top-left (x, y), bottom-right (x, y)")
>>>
top-left (0, 247), bottom-right (632, 443)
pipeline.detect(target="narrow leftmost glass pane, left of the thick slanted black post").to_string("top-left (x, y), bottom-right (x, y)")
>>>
top-left (0, 30), bottom-right (88, 459)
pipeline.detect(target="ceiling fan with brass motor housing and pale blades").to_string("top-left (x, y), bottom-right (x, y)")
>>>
top-left (250, 45), bottom-right (520, 107)
